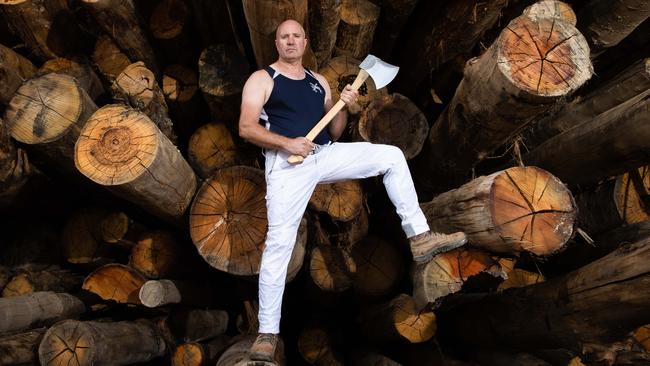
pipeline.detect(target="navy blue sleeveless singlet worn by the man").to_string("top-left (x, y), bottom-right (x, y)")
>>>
top-left (260, 66), bottom-right (330, 144)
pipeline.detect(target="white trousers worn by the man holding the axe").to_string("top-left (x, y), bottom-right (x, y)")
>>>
top-left (259, 142), bottom-right (429, 334)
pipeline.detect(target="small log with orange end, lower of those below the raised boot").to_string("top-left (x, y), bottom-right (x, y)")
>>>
top-left (361, 294), bottom-right (436, 343)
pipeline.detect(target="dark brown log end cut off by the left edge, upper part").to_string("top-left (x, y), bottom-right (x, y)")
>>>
top-left (0, 45), bottom-right (36, 104)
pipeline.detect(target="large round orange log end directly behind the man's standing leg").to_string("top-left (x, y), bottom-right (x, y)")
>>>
top-left (190, 166), bottom-right (267, 275)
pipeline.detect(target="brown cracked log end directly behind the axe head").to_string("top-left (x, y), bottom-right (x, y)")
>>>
top-left (318, 56), bottom-right (387, 114)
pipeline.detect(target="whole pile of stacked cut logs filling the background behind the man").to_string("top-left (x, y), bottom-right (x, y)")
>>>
top-left (0, 0), bottom-right (650, 366)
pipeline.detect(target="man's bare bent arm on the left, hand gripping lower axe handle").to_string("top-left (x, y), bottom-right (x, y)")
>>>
top-left (239, 70), bottom-right (314, 157)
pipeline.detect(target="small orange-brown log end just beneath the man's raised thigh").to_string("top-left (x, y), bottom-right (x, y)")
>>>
top-left (309, 180), bottom-right (363, 221)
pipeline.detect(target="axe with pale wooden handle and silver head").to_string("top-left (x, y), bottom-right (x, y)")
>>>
top-left (287, 55), bottom-right (399, 165)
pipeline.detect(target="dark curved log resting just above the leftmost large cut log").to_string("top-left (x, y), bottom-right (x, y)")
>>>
top-left (37, 57), bottom-right (104, 100)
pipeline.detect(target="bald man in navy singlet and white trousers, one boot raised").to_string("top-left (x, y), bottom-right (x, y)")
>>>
top-left (239, 20), bottom-right (467, 361)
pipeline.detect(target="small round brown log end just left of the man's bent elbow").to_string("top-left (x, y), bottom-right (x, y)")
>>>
top-left (187, 123), bottom-right (239, 179)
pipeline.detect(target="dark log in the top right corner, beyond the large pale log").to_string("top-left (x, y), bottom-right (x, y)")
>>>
top-left (578, 0), bottom-right (650, 57)
